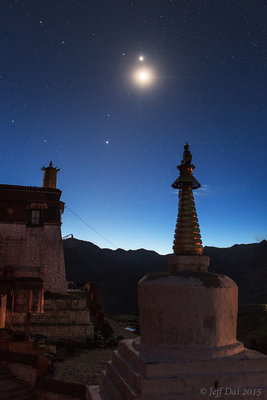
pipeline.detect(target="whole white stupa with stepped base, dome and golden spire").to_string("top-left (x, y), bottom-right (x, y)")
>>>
top-left (89, 144), bottom-right (267, 400)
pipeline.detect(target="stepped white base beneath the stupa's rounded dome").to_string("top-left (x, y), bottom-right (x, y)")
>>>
top-left (89, 339), bottom-right (267, 400)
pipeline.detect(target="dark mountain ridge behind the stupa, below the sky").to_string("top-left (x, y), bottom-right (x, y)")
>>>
top-left (63, 239), bottom-right (267, 314)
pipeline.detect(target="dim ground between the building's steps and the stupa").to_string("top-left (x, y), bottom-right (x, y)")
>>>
top-left (53, 319), bottom-right (136, 385)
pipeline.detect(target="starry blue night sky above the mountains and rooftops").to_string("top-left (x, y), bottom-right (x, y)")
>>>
top-left (0, 0), bottom-right (267, 254)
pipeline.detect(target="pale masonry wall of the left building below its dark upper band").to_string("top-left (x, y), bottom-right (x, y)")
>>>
top-left (0, 223), bottom-right (67, 293)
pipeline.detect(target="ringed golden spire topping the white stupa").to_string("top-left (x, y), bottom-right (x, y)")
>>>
top-left (172, 143), bottom-right (203, 256)
